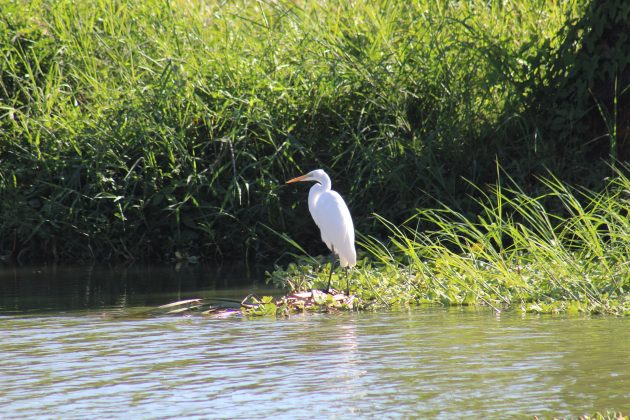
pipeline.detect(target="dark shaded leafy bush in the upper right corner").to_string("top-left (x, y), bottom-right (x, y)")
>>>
top-left (531, 0), bottom-right (630, 167)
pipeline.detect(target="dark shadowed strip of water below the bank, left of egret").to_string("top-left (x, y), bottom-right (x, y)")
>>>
top-left (0, 265), bottom-right (275, 314)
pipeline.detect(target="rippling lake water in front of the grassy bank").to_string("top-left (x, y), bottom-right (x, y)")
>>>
top-left (0, 269), bottom-right (630, 418)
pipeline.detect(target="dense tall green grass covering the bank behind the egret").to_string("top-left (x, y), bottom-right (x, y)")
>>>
top-left (0, 0), bottom-right (630, 270)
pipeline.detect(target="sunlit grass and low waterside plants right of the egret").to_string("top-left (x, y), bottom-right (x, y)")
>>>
top-left (272, 169), bottom-right (630, 314)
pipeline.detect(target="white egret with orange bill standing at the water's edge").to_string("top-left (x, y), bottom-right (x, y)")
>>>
top-left (287, 169), bottom-right (357, 294)
